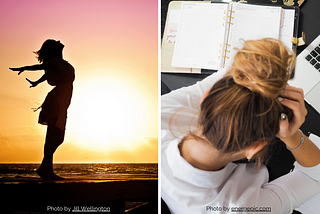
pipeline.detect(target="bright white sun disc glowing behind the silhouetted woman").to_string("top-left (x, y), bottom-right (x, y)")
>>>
top-left (68, 78), bottom-right (148, 150)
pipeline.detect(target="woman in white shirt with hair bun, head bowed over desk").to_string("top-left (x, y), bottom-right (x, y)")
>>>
top-left (161, 39), bottom-right (320, 214)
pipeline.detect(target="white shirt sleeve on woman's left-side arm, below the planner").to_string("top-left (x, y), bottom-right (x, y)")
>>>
top-left (161, 68), bottom-right (227, 130)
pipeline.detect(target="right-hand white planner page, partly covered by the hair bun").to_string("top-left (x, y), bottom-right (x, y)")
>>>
top-left (226, 3), bottom-right (282, 66)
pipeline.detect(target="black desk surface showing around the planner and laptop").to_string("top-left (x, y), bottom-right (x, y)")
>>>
top-left (161, 0), bottom-right (320, 136)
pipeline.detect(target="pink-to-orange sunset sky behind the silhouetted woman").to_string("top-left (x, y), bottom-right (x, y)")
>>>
top-left (0, 0), bottom-right (158, 163)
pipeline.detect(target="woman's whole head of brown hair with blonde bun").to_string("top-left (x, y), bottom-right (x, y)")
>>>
top-left (189, 39), bottom-right (295, 168)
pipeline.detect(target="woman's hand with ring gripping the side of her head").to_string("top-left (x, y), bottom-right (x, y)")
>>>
top-left (277, 85), bottom-right (308, 139)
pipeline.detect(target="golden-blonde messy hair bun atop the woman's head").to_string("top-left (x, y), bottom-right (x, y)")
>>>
top-left (230, 38), bottom-right (295, 98)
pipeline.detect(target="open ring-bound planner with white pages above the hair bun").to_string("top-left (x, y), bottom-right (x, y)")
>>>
top-left (163, 2), bottom-right (298, 73)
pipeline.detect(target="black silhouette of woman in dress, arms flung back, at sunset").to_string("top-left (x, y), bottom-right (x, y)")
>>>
top-left (10, 39), bottom-right (75, 180)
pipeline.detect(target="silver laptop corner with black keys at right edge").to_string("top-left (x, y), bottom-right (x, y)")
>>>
top-left (288, 35), bottom-right (320, 113)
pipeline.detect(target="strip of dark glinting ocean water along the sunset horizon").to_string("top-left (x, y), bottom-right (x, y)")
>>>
top-left (0, 163), bottom-right (158, 178)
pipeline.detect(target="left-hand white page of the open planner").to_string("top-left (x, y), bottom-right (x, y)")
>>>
top-left (172, 2), bottom-right (228, 70)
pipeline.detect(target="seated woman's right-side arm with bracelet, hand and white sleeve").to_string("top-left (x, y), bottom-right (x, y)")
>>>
top-left (252, 85), bottom-right (320, 213)
